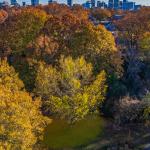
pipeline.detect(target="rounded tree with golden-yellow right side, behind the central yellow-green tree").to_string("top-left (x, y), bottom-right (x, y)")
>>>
top-left (67, 24), bottom-right (122, 74)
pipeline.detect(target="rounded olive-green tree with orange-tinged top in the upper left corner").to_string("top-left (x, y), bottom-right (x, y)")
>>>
top-left (0, 8), bottom-right (47, 53)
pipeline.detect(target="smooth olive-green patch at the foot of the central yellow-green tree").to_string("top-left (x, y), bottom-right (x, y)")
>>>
top-left (44, 116), bottom-right (104, 149)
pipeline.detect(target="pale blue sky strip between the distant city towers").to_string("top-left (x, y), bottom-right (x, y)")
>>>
top-left (0, 0), bottom-right (150, 6)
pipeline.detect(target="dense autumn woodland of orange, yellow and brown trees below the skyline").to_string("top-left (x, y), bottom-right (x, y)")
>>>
top-left (0, 4), bottom-right (150, 150)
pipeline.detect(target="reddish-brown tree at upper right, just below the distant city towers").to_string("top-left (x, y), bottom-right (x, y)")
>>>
top-left (115, 8), bottom-right (150, 49)
